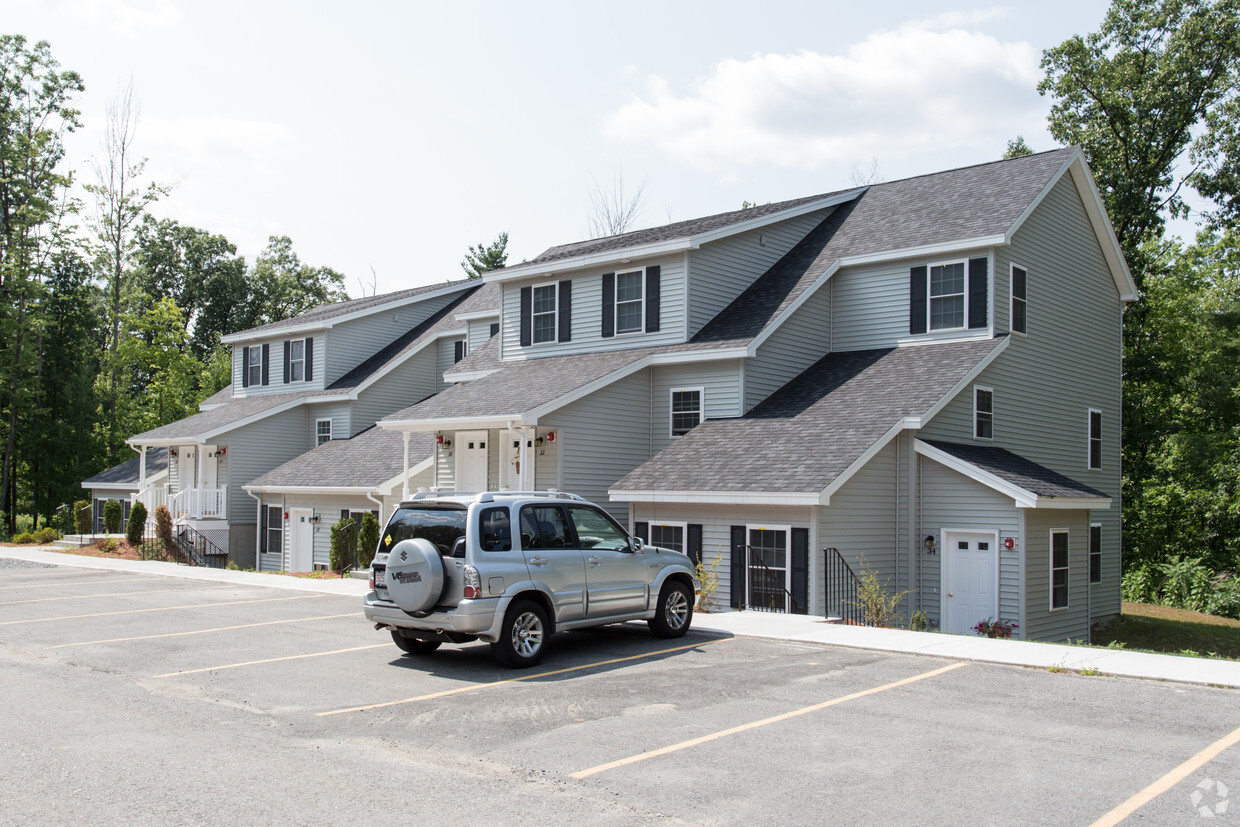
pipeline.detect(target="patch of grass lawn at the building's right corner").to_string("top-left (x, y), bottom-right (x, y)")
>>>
top-left (1094, 603), bottom-right (1240, 661)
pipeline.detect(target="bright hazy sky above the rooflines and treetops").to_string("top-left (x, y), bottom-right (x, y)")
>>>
top-left (9, 0), bottom-right (1107, 296)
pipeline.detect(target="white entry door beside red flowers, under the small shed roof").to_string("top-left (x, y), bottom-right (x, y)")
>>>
top-left (942, 531), bottom-right (999, 635)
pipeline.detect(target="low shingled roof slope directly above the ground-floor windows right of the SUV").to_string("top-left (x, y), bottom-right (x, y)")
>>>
top-left (613, 338), bottom-right (1003, 493)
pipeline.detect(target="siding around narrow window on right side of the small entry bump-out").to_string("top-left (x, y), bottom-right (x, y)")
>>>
top-left (1024, 510), bottom-right (1097, 641)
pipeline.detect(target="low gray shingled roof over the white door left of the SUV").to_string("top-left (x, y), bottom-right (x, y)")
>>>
top-left (246, 428), bottom-right (435, 489)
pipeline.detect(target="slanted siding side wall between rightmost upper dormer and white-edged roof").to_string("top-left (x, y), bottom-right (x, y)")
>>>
top-left (745, 281), bottom-right (832, 412)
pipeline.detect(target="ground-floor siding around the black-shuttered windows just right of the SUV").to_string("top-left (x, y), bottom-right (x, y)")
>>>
top-left (629, 502), bottom-right (822, 615)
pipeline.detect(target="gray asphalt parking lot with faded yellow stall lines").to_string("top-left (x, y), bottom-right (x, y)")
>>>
top-left (0, 551), bottom-right (1240, 823)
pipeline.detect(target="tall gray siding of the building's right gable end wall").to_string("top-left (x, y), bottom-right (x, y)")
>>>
top-left (922, 176), bottom-right (1122, 617)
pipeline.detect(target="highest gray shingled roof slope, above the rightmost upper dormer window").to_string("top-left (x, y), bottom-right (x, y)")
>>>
top-left (691, 149), bottom-right (1075, 347)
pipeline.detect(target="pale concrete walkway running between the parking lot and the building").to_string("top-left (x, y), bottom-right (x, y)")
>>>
top-left (0, 547), bottom-right (1240, 688)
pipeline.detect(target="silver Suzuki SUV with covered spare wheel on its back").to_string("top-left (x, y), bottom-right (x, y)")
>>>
top-left (366, 491), bottom-right (701, 668)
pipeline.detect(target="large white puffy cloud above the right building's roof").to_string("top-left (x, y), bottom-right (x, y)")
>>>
top-left (605, 18), bottom-right (1045, 171)
